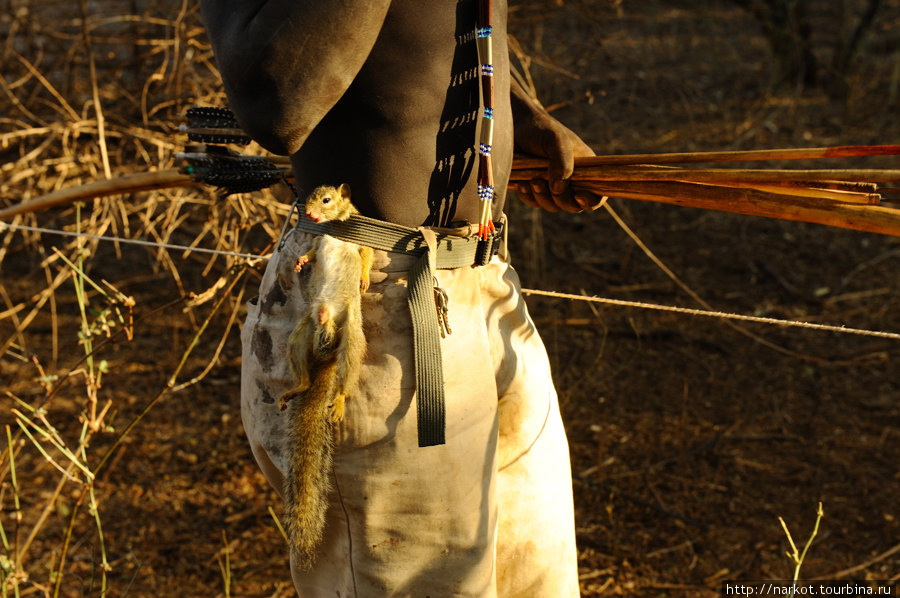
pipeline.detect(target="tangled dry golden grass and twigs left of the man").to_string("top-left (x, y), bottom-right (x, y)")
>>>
top-left (0, 1), bottom-right (286, 596)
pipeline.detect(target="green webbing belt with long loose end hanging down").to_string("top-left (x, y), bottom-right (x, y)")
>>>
top-left (296, 210), bottom-right (500, 447)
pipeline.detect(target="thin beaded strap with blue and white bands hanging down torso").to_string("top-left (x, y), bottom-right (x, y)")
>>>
top-left (475, 0), bottom-right (494, 239)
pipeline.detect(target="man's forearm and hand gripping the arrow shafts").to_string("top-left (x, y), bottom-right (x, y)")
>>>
top-left (510, 78), bottom-right (602, 212)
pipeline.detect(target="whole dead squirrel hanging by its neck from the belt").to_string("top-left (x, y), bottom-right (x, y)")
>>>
top-left (279, 185), bottom-right (373, 569)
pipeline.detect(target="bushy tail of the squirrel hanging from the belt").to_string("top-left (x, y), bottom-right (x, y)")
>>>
top-left (284, 359), bottom-right (337, 570)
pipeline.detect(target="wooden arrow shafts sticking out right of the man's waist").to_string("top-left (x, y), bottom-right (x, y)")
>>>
top-left (510, 145), bottom-right (900, 236)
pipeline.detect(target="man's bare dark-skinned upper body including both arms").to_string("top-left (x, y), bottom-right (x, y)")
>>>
top-left (201, 0), bottom-right (599, 226)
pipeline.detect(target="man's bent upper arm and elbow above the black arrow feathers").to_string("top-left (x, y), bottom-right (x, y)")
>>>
top-left (200, 0), bottom-right (390, 155)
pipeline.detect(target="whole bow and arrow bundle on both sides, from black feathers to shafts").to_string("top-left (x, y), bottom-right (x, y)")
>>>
top-left (0, 107), bottom-right (900, 236)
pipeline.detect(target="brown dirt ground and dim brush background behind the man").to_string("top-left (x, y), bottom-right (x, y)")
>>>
top-left (0, 0), bottom-right (900, 598)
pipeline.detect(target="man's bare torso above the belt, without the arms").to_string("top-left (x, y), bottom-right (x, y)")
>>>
top-left (293, 0), bottom-right (512, 226)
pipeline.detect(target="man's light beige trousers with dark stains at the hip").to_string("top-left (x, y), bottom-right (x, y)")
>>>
top-left (241, 231), bottom-right (579, 598)
